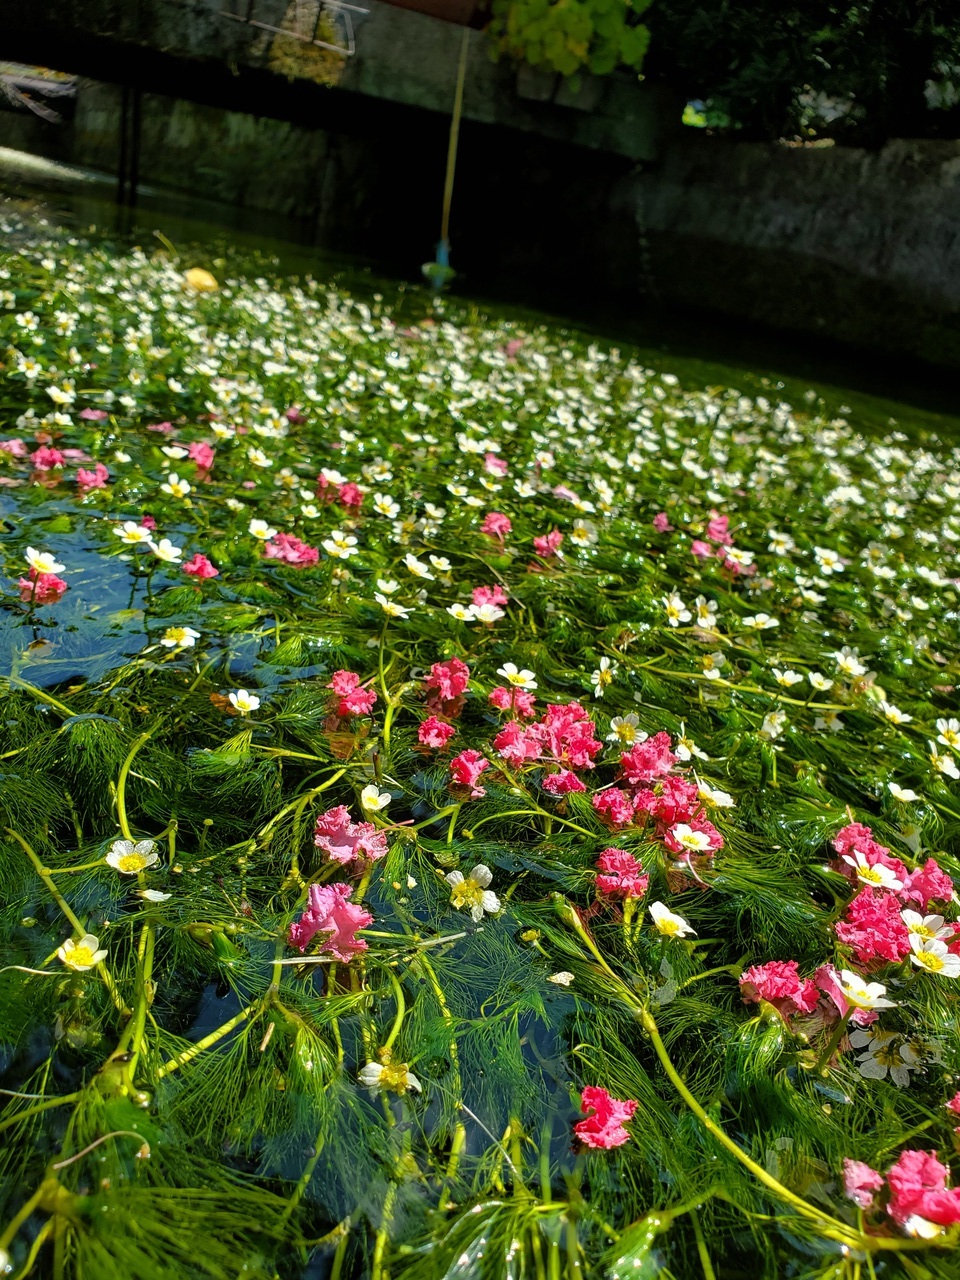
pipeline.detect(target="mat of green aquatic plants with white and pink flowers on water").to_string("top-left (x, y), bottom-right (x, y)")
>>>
top-left (0, 216), bottom-right (960, 1280)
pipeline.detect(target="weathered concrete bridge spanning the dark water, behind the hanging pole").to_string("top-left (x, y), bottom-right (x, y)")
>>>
top-left (0, 0), bottom-right (667, 161)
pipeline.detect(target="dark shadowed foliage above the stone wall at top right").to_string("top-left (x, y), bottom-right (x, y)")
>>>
top-left (648, 0), bottom-right (960, 146)
